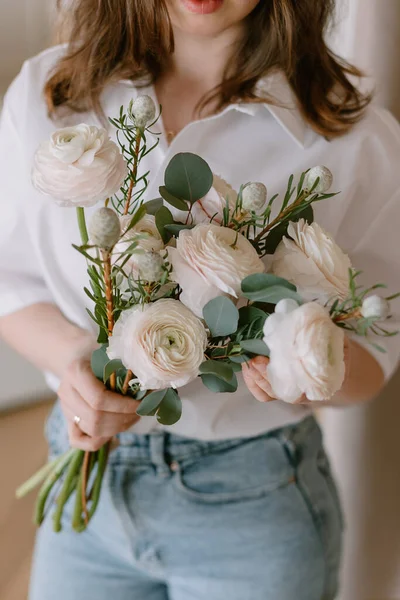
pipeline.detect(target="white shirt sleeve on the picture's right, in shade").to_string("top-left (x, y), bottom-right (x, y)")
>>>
top-left (339, 106), bottom-right (400, 381)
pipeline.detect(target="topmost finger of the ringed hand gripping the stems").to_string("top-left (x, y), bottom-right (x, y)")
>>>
top-left (71, 361), bottom-right (139, 414)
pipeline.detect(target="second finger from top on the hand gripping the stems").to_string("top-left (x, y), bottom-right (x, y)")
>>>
top-left (63, 388), bottom-right (140, 437)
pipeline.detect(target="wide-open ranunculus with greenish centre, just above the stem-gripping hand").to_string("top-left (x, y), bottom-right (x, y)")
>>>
top-left (107, 299), bottom-right (207, 390)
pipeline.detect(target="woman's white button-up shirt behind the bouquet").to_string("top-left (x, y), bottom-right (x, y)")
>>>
top-left (0, 46), bottom-right (400, 440)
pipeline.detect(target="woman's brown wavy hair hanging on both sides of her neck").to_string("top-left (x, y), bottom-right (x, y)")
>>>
top-left (45, 0), bottom-right (371, 138)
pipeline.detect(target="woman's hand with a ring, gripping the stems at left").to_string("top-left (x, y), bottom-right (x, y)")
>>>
top-left (58, 357), bottom-right (140, 452)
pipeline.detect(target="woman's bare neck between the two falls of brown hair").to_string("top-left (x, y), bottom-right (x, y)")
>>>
top-left (165, 27), bottom-right (242, 92)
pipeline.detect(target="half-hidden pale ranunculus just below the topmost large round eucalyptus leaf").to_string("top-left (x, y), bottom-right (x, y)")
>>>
top-left (168, 175), bottom-right (238, 225)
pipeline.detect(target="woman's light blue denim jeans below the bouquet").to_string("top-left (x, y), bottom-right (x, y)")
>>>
top-left (29, 407), bottom-right (342, 600)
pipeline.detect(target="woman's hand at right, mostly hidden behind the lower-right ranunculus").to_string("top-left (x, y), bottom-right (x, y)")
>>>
top-left (242, 336), bottom-right (350, 407)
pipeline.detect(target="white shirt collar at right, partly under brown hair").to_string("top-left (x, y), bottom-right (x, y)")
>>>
top-left (236, 71), bottom-right (309, 148)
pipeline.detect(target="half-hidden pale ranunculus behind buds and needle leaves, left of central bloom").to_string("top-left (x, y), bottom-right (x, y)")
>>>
top-left (114, 215), bottom-right (164, 278)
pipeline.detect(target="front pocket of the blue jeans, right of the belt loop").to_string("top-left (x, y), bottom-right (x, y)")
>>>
top-left (175, 438), bottom-right (294, 503)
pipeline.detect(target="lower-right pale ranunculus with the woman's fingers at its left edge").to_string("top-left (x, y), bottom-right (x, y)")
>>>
top-left (264, 302), bottom-right (345, 403)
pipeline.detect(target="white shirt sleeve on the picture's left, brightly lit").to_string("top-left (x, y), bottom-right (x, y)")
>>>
top-left (0, 75), bottom-right (53, 316)
